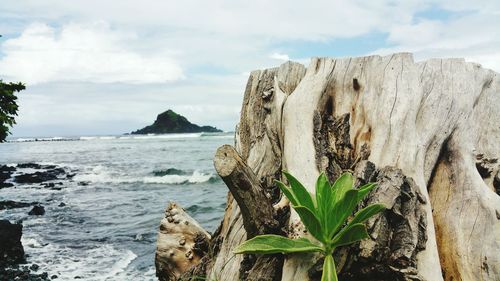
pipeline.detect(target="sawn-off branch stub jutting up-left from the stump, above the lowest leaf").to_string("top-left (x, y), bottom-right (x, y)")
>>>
top-left (214, 145), bottom-right (279, 239)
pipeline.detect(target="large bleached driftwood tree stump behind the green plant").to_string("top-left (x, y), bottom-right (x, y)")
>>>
top-left (157, 54), bottom-right (500, 281)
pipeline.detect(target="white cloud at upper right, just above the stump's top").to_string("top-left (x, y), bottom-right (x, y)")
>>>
top-left (372, 9), bottom-right (500, 72)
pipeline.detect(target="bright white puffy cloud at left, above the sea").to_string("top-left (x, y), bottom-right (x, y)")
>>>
top-left (0, 21), bottom-right (183, 84)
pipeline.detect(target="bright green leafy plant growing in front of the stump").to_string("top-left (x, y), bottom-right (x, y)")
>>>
top-left (235, 172), bottom-right (385, 281)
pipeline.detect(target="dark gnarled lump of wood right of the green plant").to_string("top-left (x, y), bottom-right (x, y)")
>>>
top-left (336, 161), bottom-right (427, 281)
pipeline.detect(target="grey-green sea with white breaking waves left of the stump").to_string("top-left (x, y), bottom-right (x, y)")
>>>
top-left (0, 133), bottom-right (234, 280)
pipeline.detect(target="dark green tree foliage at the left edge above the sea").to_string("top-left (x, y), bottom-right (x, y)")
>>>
top-left (0, 80), bottom-right (26, 142)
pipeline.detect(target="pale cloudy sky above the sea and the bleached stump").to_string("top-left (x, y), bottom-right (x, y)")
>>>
top-left (0, 0), bottom-right (500, 136)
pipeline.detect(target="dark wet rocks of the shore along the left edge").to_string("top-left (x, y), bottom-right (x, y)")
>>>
top-left (0, 163), bottom-right (75, 281)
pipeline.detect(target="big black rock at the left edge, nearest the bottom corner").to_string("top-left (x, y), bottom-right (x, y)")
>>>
top-left (0, 220), bottom-right (25, 264)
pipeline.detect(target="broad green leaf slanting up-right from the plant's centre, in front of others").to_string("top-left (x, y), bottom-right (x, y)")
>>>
top-left (325, 189), bottom-right (358, 238)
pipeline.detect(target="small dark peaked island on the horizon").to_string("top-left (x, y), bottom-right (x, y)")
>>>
top-left (131, 109), bottom-right (222, 135)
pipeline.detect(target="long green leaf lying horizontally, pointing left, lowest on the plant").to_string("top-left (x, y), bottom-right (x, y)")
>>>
top-left (234, 234), bottom-right (322, 254)
